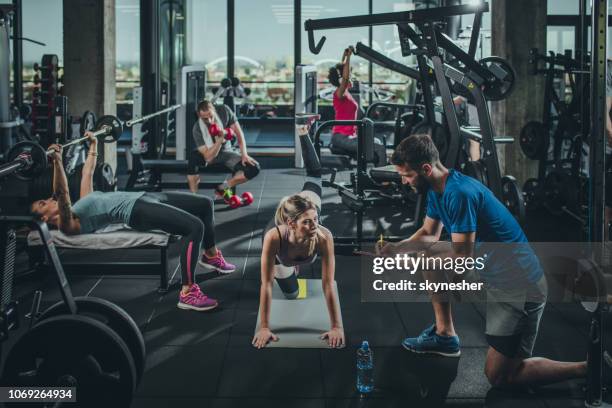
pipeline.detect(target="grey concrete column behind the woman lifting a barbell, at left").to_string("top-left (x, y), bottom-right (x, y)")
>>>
top-left (63, 0), bottom-right (117, 171)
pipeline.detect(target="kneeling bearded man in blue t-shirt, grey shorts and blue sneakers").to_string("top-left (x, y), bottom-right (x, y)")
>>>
top-left (380, 134), bottom-right (586, 386)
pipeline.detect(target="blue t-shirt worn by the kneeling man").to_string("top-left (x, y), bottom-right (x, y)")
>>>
top-left (427, 170), bottom-right (543, 287)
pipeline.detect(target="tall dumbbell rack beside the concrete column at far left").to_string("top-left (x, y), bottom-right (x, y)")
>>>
top-left (32, 54), bottom-right (61, 147)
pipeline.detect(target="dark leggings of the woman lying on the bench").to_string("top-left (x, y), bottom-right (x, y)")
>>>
top-left (130, 192), bottom-right (215, 285)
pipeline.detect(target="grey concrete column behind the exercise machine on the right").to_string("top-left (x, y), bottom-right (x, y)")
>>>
top-left (491, 0), bottom-right (547, 185)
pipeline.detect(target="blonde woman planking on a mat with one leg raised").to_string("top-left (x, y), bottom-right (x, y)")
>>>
top-left (252, 126), bottom-right (345, 348)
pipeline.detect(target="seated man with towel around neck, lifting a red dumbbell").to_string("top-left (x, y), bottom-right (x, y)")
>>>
top-left (187, 99), bottom-right (259, 203)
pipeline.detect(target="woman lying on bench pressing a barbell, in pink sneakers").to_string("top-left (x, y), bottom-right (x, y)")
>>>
top-left (30, 132), bottom-right (236, 311)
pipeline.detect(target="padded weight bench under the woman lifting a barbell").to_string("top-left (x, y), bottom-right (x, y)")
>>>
top-left (27, 224), bottom-right (175, 293)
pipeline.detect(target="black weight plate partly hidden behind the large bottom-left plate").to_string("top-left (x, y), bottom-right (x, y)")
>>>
top-left (38, 296), bottom-right (146, 381)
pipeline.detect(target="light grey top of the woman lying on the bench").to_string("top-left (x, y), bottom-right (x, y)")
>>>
top-left (72, 191), bottom-right (144, 234)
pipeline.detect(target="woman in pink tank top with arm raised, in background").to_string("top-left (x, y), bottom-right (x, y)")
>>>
top-left (327, 48), bottom-right (387, 167)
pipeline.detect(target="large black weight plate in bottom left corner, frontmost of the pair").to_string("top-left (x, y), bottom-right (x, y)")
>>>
top-left (0, 315), bottom-right (136, 408)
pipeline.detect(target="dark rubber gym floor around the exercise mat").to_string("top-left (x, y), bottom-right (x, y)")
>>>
top-left (3, 169), bottom-right (610, 408)
